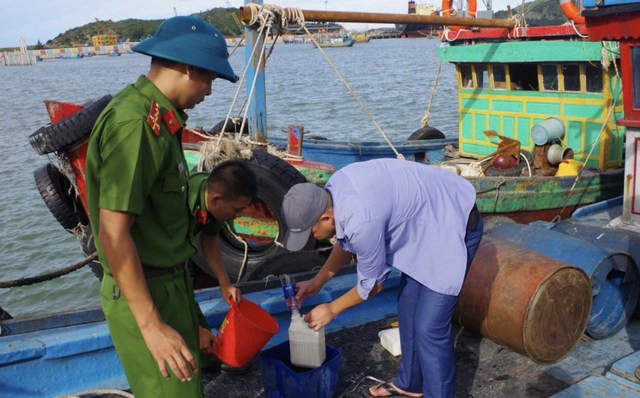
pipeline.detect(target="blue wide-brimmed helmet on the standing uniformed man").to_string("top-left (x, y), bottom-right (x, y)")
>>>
top-left (132, 16), bottom-right (238, 83)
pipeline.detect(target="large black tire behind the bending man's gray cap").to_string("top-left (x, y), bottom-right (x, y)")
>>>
top-left (220, 151), bottom-right (315, 281)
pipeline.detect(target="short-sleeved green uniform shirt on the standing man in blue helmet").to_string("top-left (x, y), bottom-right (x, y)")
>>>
top-left (86, 76), bottom-right (197, 271)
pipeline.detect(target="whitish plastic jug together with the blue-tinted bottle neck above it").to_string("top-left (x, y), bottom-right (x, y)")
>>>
top-left (280, 274), bottom-right (327, 368)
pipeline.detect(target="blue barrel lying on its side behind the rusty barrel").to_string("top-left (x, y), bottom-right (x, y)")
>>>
top-left (488, 224), bottom-right (640, 339)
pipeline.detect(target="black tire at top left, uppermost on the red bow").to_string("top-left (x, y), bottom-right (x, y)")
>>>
top-left (29, 95), bottom-right (111, 155)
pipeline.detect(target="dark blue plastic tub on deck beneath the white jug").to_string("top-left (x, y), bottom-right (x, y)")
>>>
top-left (260, 340), bottom-right (342, 398)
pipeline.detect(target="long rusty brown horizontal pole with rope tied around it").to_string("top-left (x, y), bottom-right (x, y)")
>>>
top-left (240, 7), bottom-right (516, 29)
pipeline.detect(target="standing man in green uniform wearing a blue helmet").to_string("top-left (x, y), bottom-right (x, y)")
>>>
top-left (86, 16), bottom-right (237, 398)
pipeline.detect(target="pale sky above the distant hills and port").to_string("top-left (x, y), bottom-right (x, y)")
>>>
top-left (0, 0), bottom-right (522, 47)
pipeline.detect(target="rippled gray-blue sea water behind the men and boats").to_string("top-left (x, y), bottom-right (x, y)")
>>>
top-left (0, 39), bottom-right (458, 317)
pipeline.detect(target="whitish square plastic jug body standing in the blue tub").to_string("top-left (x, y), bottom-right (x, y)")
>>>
top-left (289, 311), bottom-right (327, 368)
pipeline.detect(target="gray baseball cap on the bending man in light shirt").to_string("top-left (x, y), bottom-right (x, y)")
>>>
top-left (282, 182), bottom-right (329, 251)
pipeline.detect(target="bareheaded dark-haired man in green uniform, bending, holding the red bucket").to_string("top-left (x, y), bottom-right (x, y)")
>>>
top-left (189, 160), bottom-right (258, 355)
